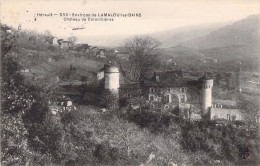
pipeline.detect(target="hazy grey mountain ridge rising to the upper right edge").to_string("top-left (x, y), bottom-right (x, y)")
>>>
top-left (180, 15), bottom-right (260, 49)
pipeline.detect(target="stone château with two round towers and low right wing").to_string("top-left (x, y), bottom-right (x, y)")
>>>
top-left (97, 65), bottom-right (259, 121)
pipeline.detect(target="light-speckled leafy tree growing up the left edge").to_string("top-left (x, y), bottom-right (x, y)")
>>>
top-left (1, 25), bottom-right (38, 165)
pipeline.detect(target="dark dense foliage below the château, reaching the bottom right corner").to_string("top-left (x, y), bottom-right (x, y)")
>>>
top-left (127, 107), bottom-right (260, 165)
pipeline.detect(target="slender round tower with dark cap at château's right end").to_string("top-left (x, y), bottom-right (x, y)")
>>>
top-left (199, 74), bottom-right (213, 117)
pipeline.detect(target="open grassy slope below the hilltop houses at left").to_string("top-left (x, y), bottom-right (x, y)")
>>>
top-left (14, 46), bottom-right (105, 83)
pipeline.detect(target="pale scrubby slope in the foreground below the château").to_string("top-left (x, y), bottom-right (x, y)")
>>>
top-left (69, 106), bottom-right (191, 166)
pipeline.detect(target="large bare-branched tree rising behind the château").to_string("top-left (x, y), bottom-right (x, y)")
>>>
top-left (118, 36), bottom-right (160, 81)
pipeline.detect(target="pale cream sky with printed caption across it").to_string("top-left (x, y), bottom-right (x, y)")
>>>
top-left (1, 0), bottom-right (260, 41)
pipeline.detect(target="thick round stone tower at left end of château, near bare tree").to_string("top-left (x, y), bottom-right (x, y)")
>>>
top-left (104, 64), bottom-right (120, 95)
